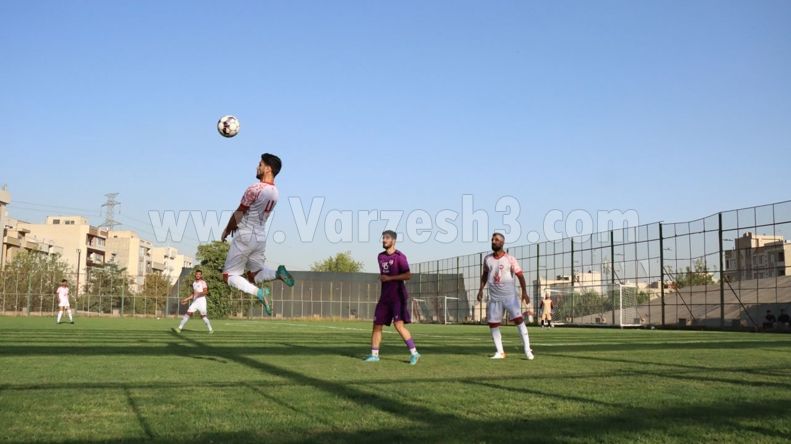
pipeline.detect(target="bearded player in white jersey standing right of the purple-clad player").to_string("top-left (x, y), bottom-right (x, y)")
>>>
top-left (478, 233), bottom-right (533, 360)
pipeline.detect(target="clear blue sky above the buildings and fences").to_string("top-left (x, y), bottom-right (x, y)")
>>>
top-left (0, 1), bottom-right (791, 270)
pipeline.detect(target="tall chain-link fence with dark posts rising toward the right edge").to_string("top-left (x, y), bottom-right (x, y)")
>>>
top-left (409, 201), bottom-right (791, 328)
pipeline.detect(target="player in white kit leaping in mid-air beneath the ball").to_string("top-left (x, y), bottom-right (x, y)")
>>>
top-left (222, 153), bottom-right (294, 315)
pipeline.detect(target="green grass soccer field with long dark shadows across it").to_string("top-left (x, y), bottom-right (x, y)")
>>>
top-left (0, 318), bottom-right (791, 443)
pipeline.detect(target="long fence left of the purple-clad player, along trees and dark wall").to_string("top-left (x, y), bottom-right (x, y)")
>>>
top-left (0, 269), bottom-right (380, 319)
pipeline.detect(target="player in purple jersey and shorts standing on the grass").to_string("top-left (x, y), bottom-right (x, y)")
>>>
top-left (365, 230), bottom-right (420, 365)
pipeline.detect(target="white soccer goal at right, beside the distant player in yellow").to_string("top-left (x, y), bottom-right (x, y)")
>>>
top-left (535, 283), bottom-right (648, 327)
